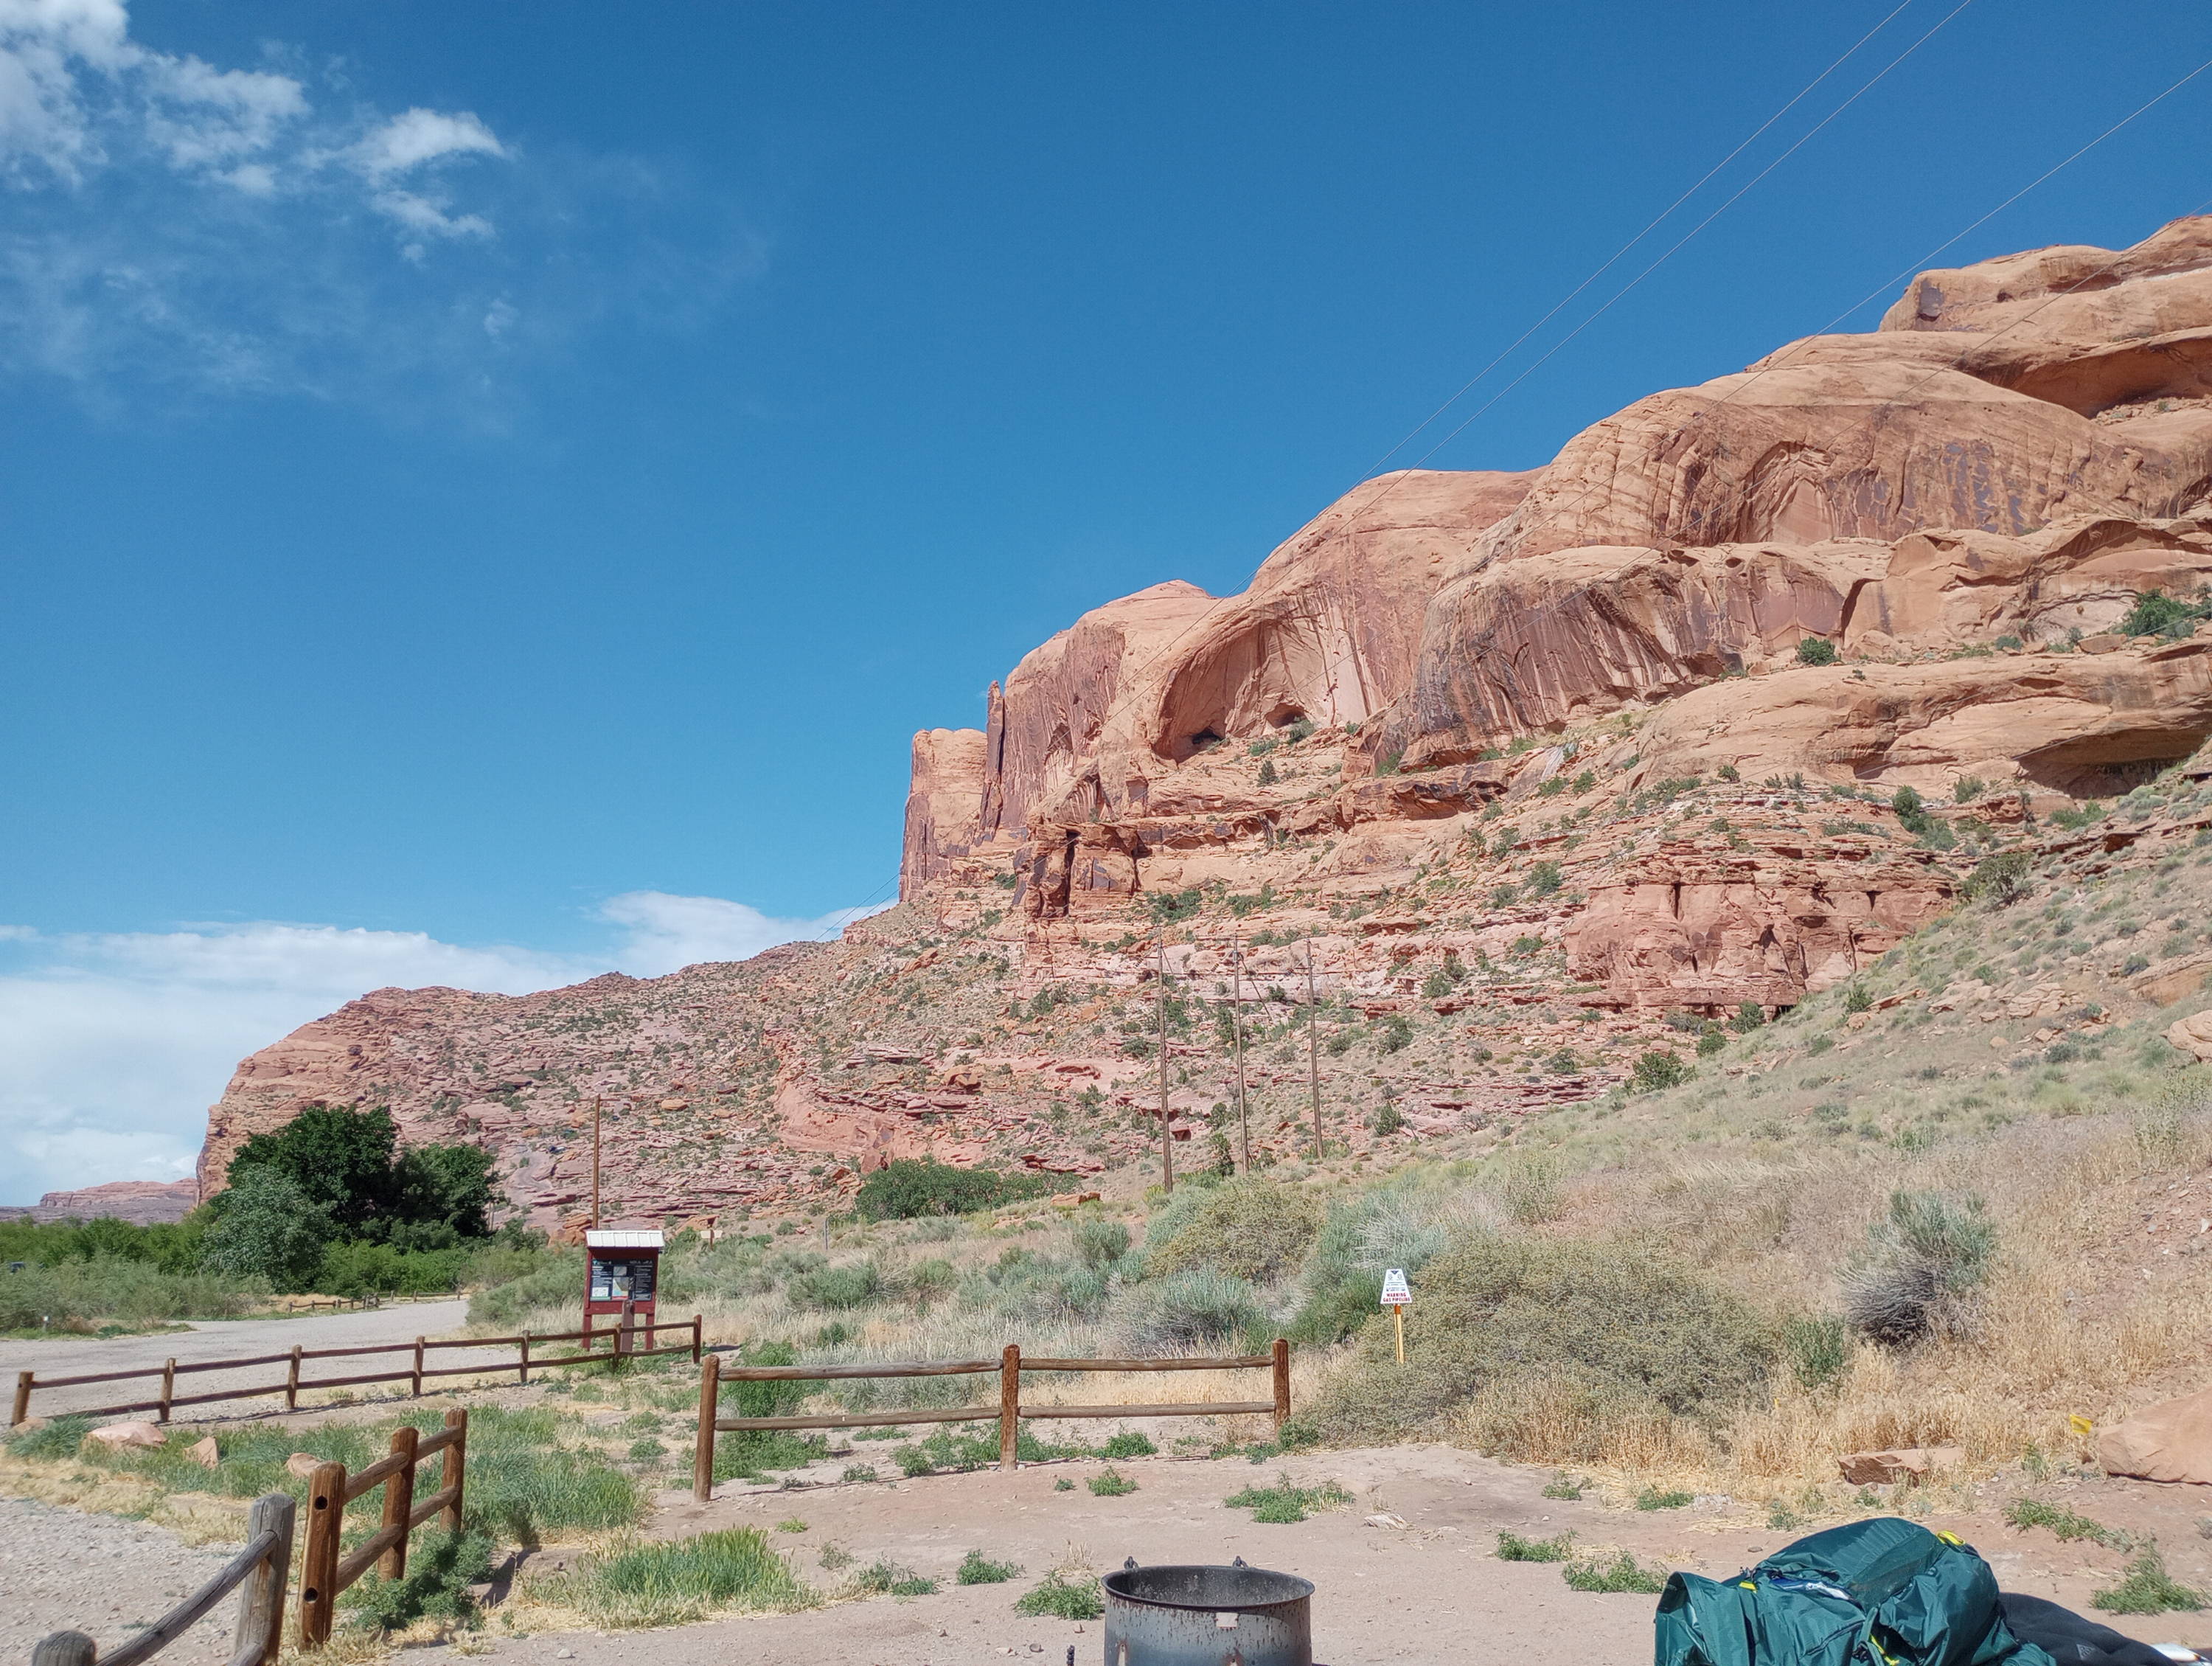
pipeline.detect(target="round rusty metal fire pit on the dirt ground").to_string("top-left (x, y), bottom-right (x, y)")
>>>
top-left (1102, 1555), bottom-right (1314, 1666)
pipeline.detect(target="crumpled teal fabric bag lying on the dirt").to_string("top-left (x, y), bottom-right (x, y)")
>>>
top-left (1652, 1516), bottom-right (2055, 1666)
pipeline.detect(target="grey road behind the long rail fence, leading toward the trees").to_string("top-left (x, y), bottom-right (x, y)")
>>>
top-left (0, 1299), bottom-right (513, 1423)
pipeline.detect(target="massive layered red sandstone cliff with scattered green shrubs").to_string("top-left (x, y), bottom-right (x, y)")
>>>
top-left (186, 219), bottom-right (2212, 1228)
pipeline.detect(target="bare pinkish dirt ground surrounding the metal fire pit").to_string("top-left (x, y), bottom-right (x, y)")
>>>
top-left (429, 1447), bottom-right (2212, 1666)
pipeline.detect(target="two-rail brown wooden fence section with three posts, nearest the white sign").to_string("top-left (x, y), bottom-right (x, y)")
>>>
top-left (692, 1336), bottom-right (1290, 1498)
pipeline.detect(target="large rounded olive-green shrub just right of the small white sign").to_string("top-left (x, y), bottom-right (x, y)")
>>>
top-left (1316, 1232), bottom-right (1776, 1462)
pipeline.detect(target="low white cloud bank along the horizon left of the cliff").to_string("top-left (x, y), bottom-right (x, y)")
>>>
top-left (0, 892), bottom-right (880, 1204)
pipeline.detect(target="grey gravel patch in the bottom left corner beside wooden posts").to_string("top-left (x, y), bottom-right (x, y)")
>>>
top-left (0, 1498), bottom-right (237, 1666)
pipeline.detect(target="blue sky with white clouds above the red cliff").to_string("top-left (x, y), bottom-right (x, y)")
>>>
top-left (0, 0), bottom-right (2212, 1201)
